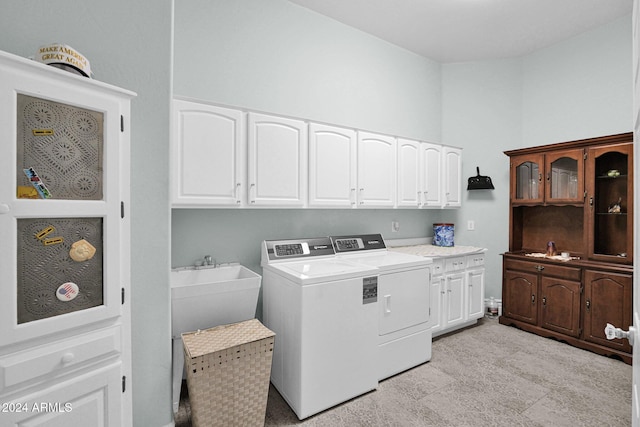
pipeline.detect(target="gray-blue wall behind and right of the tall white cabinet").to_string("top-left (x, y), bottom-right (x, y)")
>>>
top-left (0, 0), bottom-right (172, 427)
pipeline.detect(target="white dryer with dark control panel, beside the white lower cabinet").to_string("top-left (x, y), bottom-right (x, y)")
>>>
top-left (330, 234), bottom-right (433, 380)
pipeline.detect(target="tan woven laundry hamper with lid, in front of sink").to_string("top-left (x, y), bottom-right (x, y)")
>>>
top-left (182, 319), bottom-right (275, 427)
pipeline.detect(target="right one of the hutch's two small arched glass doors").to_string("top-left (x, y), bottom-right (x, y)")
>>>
top-left (545, 148), bottom-right (584, 203)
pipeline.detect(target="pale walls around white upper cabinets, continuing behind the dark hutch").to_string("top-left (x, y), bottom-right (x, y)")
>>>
top-left (171, 0), bottom-right (631, 304)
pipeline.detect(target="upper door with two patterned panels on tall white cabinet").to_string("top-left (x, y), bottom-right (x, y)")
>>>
top-left (0, 57), bottom-right (132, 347)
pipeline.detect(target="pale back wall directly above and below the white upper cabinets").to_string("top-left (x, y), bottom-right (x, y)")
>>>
top-left (171, 0), bottom-right (448, 272)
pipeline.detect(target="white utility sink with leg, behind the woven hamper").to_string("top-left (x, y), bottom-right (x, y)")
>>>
top-left (170, 264), bottom-right (262, 412)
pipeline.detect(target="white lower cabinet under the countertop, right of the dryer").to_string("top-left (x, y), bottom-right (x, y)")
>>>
top-left (430, 254), bottom-right (485, 336)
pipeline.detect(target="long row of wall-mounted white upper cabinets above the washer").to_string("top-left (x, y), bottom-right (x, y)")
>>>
top-left (171, 98), bottom-right (462, 208)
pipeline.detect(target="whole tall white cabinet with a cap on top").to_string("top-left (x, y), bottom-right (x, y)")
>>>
top-left (0, 52), bottom-right (135, 427)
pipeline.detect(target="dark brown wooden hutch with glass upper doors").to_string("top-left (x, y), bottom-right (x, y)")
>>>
top-left (500, 132), bottom-right (633, 363)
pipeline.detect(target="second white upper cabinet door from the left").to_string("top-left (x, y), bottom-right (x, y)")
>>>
top-left (248, 113), bottom-right (308, 207)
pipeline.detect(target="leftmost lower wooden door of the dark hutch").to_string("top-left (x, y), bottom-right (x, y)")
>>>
top-left (502, 270), bottom-right (538, 325)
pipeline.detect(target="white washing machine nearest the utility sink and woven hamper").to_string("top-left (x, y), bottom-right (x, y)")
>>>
top-left (262, 237), bottom-right (378, 419)
